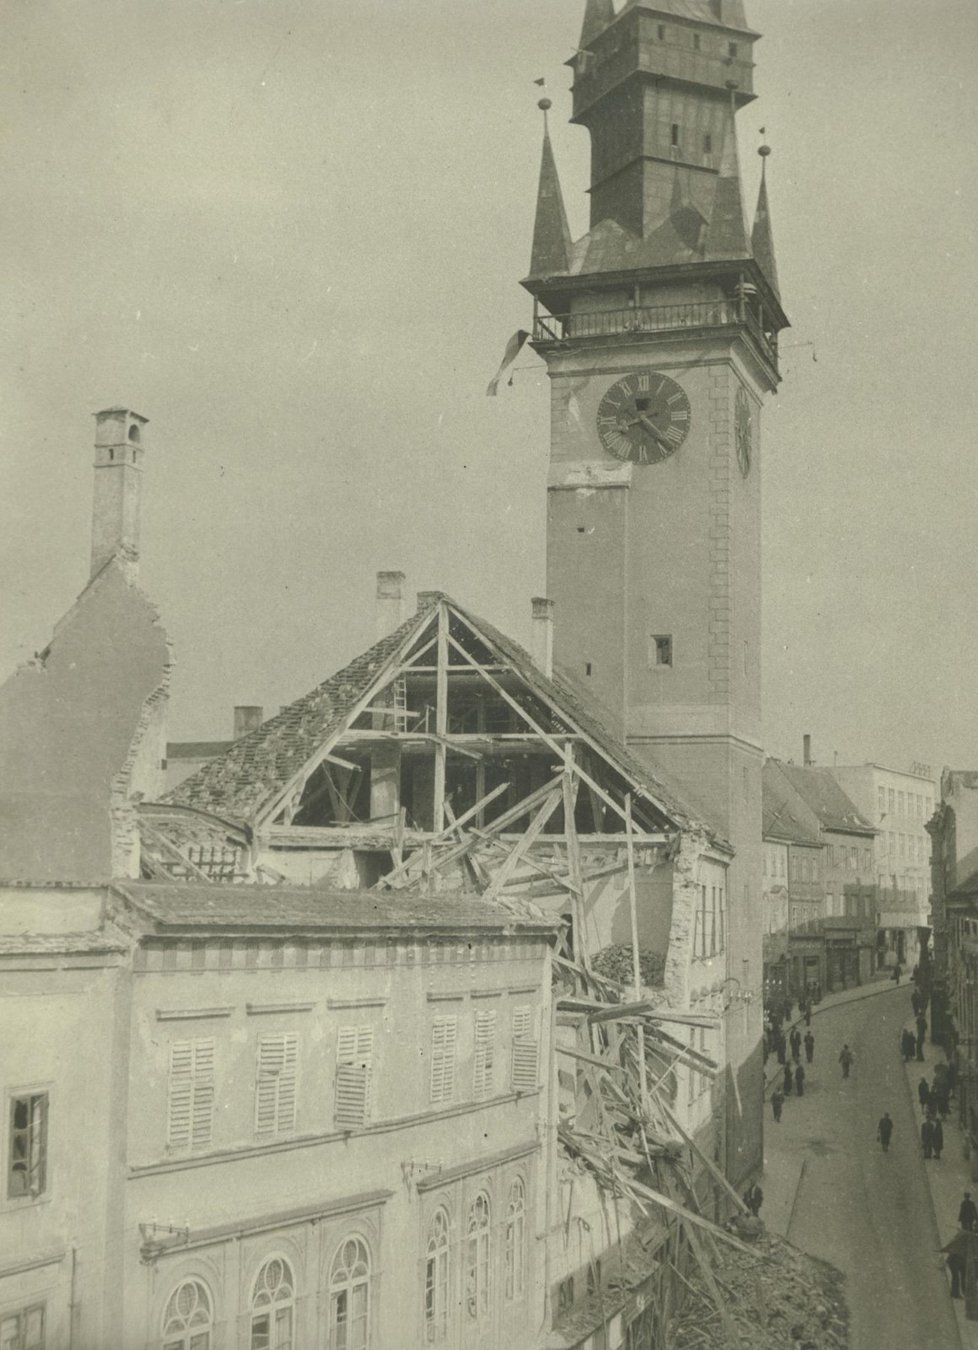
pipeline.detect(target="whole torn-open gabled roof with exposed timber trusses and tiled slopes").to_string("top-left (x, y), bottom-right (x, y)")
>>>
top-left (165, 593), bottom-right (723, 848)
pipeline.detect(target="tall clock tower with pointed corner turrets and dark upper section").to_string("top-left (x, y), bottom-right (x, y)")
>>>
top-left (524, 0), bottom-right (788, 1183)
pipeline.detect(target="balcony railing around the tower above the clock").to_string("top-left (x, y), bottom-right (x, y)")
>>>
top-left (534, 300), bottom-right (778, 363)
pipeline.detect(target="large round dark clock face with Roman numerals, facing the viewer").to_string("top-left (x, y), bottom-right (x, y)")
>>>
top-left (597, 370), bottom-right (690, 464)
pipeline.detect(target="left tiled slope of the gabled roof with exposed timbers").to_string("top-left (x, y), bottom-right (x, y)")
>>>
top-left (163, 595), bottom-right (438, 821)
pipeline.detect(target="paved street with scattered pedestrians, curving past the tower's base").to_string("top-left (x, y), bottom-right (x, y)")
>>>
top-left (766, 986), bottom-right (960, 1350)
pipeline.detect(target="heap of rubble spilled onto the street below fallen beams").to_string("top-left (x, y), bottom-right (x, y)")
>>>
top-left (670, 1220), bottom-right (848, 1350)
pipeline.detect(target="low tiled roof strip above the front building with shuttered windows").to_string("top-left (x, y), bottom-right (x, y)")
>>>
top-left (113, 882), bottom-right (557, 933)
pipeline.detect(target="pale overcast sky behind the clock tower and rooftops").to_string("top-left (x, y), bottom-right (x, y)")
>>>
top-left (0, 0), bottom-right (978, 770)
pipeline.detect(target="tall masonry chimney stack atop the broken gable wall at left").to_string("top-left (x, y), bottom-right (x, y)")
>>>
top-left (91, 408), bottom-right (146, 576)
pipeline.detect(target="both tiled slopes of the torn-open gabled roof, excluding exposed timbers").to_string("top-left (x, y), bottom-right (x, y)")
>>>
top-left (163, 591), bottom-right (729, 848)
